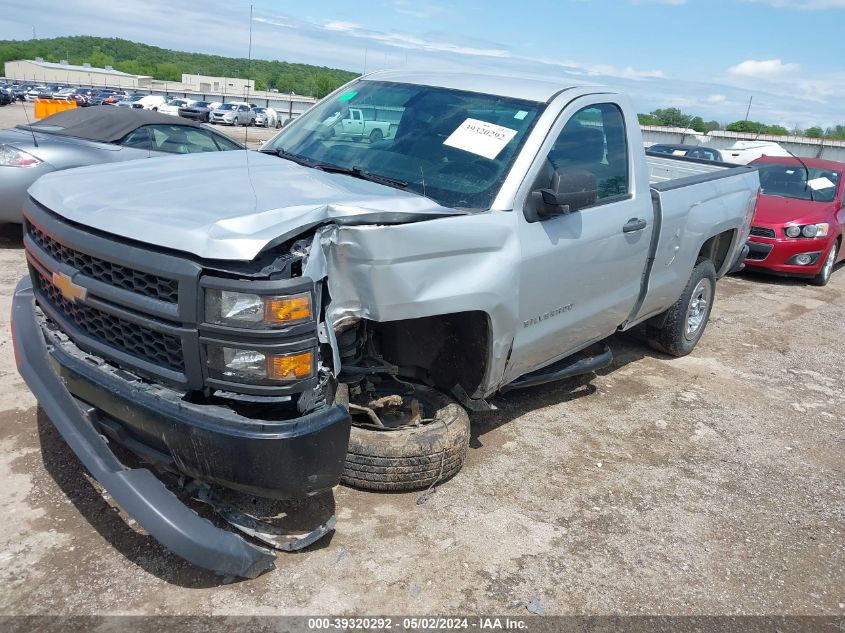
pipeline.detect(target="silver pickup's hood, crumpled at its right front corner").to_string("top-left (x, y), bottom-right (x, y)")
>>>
top-left (29, 151), bottom-right (464, 260)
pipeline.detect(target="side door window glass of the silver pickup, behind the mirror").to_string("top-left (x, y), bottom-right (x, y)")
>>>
top-left (534, 103), bottom-right (630, 203)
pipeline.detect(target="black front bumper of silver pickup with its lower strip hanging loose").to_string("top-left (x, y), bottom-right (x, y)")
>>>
top-left (12, 278), bottom-right (350, 578)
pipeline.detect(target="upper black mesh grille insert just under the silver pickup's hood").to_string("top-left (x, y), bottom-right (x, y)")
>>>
top-left (26, 222), bottom-right (179, 304)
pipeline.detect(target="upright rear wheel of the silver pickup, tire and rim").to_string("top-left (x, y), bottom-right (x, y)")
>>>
top-left (646, 259), bottom-right (716, 356)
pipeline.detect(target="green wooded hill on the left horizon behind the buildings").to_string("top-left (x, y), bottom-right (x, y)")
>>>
top-left (0, 35), bottom-right (358, 98)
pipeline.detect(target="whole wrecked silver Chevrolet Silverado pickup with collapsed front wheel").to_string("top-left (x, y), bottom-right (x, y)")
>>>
top-left (13, 72), bottom-right (759, 577)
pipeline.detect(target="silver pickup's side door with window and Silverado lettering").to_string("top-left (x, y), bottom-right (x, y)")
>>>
top-left (506, 95), bottom-right (654, 380)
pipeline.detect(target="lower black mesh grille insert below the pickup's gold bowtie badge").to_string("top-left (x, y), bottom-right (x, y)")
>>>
top-left (32, 273), bottom-right (185, 372)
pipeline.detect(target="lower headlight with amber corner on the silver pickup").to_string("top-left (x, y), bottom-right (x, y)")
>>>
top-left (207, 345), bottom-right (314, 385)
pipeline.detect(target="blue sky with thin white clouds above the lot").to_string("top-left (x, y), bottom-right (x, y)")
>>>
top-left (0, 0), bottom-right (845, 129)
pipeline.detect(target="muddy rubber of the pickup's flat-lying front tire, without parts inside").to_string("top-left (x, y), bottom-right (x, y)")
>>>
top-left (340, 385), bottom-right (470, 492)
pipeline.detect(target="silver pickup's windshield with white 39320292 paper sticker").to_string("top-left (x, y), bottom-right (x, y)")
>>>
top-left (263, 80), bottom-right (544, 210)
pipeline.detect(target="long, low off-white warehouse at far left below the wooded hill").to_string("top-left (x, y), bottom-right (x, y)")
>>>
top-left (5, 57), bottom-right (152, 90)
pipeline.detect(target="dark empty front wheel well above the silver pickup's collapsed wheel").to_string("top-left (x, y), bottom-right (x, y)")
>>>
top-left (370, 311), bottom-right (490, 395)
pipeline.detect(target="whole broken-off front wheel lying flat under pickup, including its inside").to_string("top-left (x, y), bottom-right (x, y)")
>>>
top-left (341, 383), bottom-right (470, 491)
